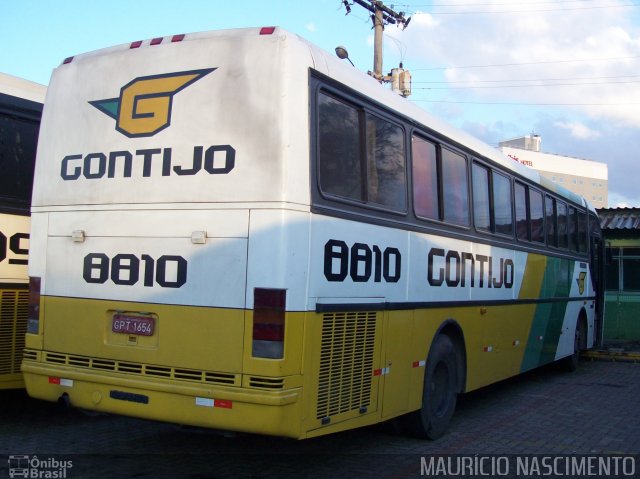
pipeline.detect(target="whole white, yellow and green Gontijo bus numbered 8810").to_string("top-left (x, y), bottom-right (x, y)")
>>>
top-left (22, 27), bottom-right (599, 438)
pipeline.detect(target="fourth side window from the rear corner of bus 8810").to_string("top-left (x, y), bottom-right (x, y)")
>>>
top-left (442, 148), bottom-right (469, 226)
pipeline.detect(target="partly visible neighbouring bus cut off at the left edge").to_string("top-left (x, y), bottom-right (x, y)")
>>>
top-left (0, 73), bottom-right (46, 389)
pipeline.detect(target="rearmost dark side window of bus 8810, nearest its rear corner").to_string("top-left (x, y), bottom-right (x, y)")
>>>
top-left (318, 93), bottom-right (364, 201)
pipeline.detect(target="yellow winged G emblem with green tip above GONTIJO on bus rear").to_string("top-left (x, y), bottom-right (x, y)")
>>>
top-left (89, 68), bottom-right (215, 138)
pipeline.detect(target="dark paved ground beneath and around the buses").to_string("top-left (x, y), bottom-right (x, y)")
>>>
top-left (0, 361), bottom-right (640, 479)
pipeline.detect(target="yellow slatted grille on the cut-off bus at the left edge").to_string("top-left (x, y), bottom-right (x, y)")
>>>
top-left (0, 289), bottom-right (29, 374)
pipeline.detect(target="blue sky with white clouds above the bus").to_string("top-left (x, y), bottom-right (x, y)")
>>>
top-left (0, 0), bottom-right (640, 206)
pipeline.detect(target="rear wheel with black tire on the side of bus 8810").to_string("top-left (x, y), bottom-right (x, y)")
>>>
top-left (404, 334), bottom-right (458, 440)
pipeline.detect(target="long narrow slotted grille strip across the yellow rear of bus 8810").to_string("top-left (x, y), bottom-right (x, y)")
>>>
top-left (43, 352), bottom-right (240, 386)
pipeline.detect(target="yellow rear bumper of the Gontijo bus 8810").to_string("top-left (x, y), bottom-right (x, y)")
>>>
top-left (22, 359), bottom-right (303, 438)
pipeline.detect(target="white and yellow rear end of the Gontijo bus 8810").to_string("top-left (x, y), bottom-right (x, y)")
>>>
top-left (23, 28), bottom-right (311, 437)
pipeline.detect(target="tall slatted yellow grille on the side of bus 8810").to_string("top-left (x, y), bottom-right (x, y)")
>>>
top-left (317, 312), bottom-right (376, 419)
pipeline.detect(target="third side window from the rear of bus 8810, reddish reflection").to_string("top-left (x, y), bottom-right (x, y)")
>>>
top-left (412, 136), bottom-right (440, 220)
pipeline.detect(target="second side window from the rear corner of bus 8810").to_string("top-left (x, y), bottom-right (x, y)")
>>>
top-left (366, 114), bottom-right (407, 211)
